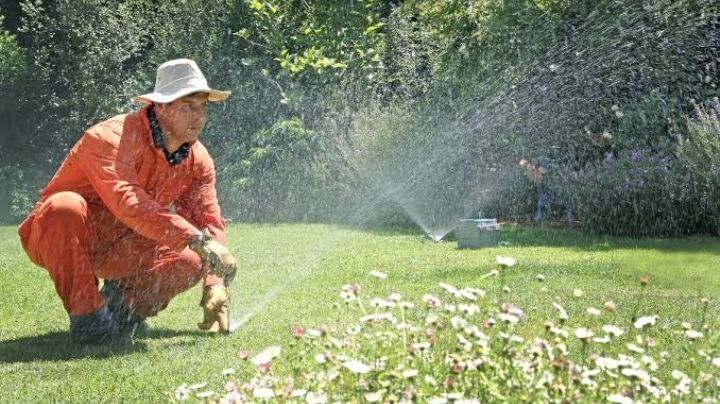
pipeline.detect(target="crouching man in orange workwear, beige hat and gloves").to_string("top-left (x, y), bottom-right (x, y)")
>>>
top-left (19, 59), bottom-right (237, 343)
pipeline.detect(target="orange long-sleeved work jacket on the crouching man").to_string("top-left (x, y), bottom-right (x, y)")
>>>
top-left (19, 108), bottom-right (225, 251)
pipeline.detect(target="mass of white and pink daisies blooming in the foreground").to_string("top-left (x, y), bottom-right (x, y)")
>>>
top-left (172, 257), bottom-right (720, 403)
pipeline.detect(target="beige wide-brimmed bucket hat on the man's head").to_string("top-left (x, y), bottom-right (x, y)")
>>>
top-left (133, 59), bottom-right (230, 104)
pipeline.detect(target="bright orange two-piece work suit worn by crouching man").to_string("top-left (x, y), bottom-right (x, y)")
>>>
top-left (18, 108), bottom-right (225, 317)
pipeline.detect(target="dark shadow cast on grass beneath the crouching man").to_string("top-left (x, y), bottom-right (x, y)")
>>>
top-left (0, 328), bottom-right (206, 363)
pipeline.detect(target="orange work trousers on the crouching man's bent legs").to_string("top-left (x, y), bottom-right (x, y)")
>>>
top-left (20, 192), bottom-right (205, 317)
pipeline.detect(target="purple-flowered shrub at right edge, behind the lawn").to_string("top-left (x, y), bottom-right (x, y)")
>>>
top-left (546, 98), bottom-right (720, 236)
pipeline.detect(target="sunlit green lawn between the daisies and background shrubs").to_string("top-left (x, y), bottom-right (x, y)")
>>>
top-left (0, 224), bottom-right (720, 403)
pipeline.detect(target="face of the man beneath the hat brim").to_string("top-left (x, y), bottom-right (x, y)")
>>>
top-left (156, 93), bottom-right (208, 143)
